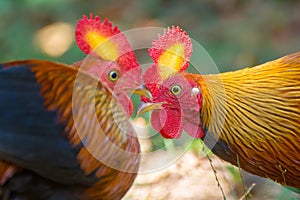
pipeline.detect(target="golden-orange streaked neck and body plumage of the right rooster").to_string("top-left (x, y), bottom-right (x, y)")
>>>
top-left (186, 52), bottom-right (300, 188)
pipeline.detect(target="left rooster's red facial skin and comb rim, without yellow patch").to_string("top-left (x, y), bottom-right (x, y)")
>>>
top-left (74, 15), bottom-right (141, 116)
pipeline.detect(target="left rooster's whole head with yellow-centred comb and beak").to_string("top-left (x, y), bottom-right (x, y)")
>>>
top-left (75, 14), bottom-right (151, 115)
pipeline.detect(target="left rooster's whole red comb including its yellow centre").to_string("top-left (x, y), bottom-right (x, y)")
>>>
top-left (76, 14), bottom-right (139, 70)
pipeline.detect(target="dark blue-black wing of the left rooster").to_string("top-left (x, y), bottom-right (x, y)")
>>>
top-left (0, 63), bottom-right (99, 183)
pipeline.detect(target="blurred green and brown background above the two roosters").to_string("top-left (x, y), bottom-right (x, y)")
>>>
top-left (0, 0), bottom-right (300, 199)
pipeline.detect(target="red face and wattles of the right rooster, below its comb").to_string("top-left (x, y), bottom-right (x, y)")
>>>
top-left (142, 67), bottom-right (204, 138)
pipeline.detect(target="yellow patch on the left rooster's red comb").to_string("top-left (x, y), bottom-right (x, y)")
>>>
top-left (86, 31), bottom-right (119, 61)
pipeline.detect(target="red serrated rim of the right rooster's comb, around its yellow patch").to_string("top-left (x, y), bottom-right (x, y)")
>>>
top-left (148, 26), bottom-right (192, 71)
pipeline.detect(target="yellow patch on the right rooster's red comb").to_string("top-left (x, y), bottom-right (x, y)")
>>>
top-left (157, 43), bottom-right (185, 80)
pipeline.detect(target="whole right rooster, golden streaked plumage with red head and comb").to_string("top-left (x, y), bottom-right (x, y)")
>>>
top-left (142, 21), bottom-right (300, 188)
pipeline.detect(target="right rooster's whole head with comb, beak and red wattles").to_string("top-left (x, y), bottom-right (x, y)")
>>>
top-left (139, 27), bottom-right (204, 138)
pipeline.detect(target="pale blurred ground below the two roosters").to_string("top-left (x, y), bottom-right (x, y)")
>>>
top-left (124, 152), bottom-right (300, 200)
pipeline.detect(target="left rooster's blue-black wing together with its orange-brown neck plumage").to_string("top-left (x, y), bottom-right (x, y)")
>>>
top-left (0, 60), bottom-right (139, 199)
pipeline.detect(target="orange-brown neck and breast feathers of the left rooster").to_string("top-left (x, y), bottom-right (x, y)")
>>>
top-left (0, 60), bottom-right (140, 199)
